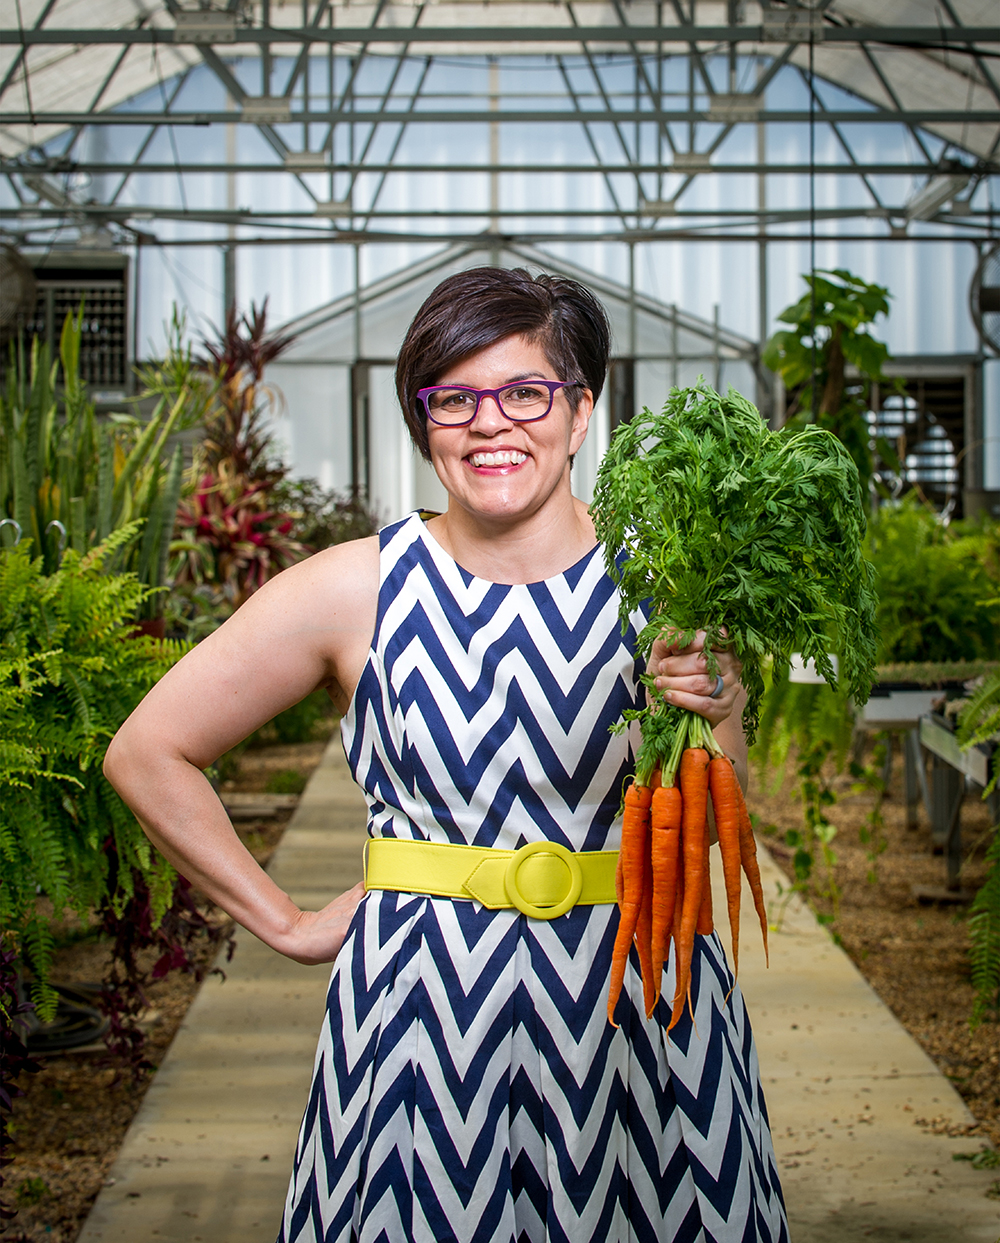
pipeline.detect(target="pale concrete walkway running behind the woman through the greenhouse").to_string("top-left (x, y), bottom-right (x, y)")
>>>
top-left (78, 736), bottom-right (1000, 1243)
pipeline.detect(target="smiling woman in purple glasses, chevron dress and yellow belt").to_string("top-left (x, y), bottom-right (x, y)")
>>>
top-left (107, 268), bottom-right (786, 1243)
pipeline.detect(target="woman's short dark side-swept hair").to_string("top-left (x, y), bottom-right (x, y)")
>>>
top-left (396, 267), bottom-right (611, 461)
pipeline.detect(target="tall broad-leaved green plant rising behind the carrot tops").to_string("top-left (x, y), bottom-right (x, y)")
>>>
top-left (761, 268), bottom-right (899, 501)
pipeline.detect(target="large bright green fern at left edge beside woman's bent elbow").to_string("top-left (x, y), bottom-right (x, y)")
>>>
top-left (0, 527), bottom-right (184, 1018)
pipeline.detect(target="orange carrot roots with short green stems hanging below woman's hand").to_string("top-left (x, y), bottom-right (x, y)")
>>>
top-left (607, 712), bottom-right (768, 1030)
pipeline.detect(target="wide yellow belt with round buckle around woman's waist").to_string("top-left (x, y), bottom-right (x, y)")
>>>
top-left (364, 838), bottom-right (619, 920)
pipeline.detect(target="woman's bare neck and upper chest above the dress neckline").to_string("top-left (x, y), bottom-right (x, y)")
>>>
top-left (427, 496), bottom-right (596, 584)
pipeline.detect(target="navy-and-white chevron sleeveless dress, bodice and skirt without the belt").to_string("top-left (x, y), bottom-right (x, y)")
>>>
top-left (280, 515), bottom-right (788, 1243)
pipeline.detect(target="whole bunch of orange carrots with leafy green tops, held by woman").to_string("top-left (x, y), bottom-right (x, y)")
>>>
top-left (590, 380), bottom-right (878, 1028)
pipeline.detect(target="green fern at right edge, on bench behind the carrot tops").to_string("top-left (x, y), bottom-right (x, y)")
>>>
top-left (867, 497), bottom-right (1000, 661)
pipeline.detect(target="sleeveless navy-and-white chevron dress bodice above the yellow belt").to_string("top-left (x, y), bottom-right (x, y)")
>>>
top-left (343, 515), bottom-right (637, 850)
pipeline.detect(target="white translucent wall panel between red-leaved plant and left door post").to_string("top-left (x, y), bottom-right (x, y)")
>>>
top-left (267, 360), bottom-right (350, 492)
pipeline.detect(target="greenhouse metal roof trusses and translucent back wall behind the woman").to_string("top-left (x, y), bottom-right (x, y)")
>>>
top-left (0, 0), bottom-right (1000, 517)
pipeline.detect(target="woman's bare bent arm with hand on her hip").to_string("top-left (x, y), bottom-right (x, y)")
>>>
top-left (104, 539), bottom-right (378, 962)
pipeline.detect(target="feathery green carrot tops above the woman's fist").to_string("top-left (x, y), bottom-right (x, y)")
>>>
top-left (591, 383), bottom-right (877, 742)
